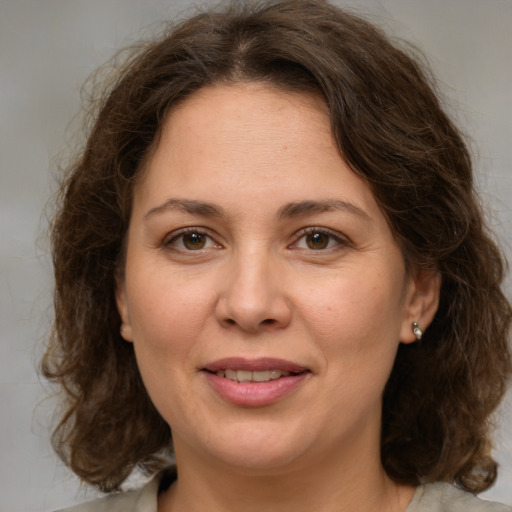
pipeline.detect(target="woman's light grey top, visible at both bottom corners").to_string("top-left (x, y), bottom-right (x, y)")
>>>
top-left (61, 475), bottom-right (512, 512)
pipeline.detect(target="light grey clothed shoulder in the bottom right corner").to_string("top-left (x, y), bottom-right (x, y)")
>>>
top-left (406, 482), bottom-right (512, 512)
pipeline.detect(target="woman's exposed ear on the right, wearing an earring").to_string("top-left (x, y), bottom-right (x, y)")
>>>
top-left (400, 269), bottom-right (441, 343)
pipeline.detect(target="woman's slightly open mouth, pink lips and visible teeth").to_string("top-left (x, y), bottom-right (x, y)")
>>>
top-left (202, 358), bottom-right (311, 407)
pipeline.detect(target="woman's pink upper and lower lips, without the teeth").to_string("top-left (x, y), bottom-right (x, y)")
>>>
top-left (202, 357), bottom-right (311, 407)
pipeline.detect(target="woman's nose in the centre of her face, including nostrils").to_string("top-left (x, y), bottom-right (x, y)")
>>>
top-left (215, 253), bottom-right (292, 333)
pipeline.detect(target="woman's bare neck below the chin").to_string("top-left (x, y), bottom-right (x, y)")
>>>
top-left (158, 428), bottom-right (414, 512)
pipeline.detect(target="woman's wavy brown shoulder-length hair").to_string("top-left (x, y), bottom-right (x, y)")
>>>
top-left (42, 0), bottom-right (511, 492)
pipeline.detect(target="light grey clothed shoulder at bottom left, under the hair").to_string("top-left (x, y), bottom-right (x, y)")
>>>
top-left (52, 474), bottom-right (162, 512)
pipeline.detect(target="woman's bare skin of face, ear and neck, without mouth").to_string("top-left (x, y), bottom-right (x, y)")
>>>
top-left (117, 84), bottom-right (439, 512)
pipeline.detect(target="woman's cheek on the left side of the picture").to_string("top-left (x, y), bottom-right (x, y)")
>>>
top-left (127, 271), bottom-right (215, 426)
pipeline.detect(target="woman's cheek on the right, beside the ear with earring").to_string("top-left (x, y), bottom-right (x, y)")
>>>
top-left (303, 265), bottom-right (403, 404)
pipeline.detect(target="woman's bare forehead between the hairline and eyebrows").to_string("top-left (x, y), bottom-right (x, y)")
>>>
top-left (132, 83), bottom-right (384, 226)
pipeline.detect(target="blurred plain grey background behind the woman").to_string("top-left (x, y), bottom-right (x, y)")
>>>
top-left (0, 0), bottom-right (512, 512)
